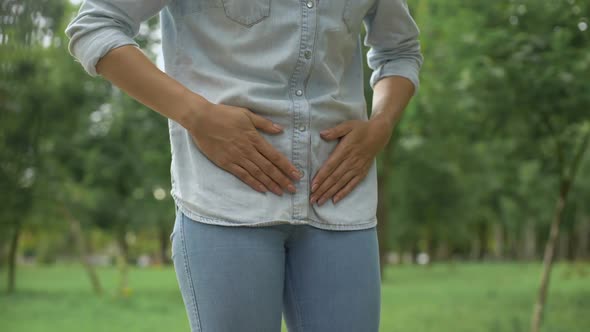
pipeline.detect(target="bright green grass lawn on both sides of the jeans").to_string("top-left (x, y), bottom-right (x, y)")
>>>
top-left (0, 264), bottom-right (590, 332)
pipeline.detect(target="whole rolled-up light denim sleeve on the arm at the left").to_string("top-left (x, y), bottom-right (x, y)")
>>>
top-left (65, 0), bottom-right (170, 76)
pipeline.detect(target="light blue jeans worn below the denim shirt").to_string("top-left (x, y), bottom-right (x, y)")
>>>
top-left (171, 206), bottom-right (381, 332)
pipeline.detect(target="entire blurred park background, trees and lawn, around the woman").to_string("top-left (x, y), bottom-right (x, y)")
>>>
top-left (0, 0), bottom-right (590, 332)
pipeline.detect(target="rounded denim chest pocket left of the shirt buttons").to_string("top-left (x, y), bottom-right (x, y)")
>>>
top-left (221, 0), bottom-right (271, 27)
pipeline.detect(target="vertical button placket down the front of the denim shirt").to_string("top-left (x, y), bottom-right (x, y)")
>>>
top-left (290, 0), bottom-right (317, 219)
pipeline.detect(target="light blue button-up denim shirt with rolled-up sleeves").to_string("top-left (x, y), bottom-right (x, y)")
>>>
top-left (66, 0), bottom-right (423, 230)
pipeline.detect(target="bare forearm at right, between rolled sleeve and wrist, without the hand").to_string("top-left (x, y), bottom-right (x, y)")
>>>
top-left (370, 76), bottom-right (415, 137)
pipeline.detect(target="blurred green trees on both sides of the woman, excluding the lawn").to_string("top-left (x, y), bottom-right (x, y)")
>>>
top-left (0, 0), bottom-right (590, 270)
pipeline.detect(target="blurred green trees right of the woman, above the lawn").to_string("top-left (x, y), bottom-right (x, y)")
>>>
top-left (380, 0), bottom-right (590, 257)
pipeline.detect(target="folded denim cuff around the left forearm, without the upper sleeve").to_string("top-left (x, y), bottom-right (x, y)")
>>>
top-left (68, 28), bottom-right (139, 77)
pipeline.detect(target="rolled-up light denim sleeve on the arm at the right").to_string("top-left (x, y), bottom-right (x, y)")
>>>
top-left (363, 0), bottom-right (423, 93)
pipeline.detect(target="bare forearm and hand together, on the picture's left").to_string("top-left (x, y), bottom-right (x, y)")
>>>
top-left (96, 45), bottom-right (300, 195)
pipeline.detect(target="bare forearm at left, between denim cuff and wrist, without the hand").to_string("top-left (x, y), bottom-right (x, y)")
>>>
top-left (96, 45), bottom-right (211, 128)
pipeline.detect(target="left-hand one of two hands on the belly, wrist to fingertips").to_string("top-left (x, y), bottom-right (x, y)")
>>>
top-left (187, 104), bottom-right (301, 195)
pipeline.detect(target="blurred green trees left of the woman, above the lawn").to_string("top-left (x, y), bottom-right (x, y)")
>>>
top-left (0, 1), bottom-right (174, 268)
